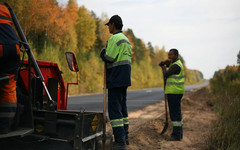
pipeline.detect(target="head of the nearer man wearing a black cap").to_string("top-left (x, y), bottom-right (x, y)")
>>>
top-left (105, 15), bottom-right (123, 34)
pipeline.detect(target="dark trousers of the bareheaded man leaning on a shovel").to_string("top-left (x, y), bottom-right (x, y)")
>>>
top-left (167, 94), bottom-right (183, 139)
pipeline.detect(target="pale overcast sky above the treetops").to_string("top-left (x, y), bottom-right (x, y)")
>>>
top-left (58, 0), bottom-right (240, 79)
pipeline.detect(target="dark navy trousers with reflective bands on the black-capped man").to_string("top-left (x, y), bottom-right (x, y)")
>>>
top-left (108, 87), bottom-right (128, 143)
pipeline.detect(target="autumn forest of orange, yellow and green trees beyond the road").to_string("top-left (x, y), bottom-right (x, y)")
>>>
top-left (6, 0), bottom-right (204, 95)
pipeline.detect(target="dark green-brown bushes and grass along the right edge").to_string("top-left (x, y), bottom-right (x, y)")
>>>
top-left (209, 66), bottom-right (240, 150)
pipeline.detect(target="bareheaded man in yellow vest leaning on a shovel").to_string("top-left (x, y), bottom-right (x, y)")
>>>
top-left (159, 49), bottom-right (185, 141)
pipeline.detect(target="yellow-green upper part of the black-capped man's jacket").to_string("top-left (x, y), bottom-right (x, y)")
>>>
top-left (104, 33), bottom-right (132, 69)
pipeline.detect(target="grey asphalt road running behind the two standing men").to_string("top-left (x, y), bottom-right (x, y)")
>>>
top-left (68, 81), bottom-right (208, 112)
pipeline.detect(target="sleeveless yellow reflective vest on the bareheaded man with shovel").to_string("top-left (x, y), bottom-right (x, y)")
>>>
top-left (165, 59), bottom-right (185, 94)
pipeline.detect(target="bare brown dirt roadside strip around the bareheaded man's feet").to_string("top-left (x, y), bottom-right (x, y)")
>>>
top-left (128, 87), bottom-right (217, 150)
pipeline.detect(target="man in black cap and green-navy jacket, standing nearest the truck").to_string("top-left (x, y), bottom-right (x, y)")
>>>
top-left (100, 15), bottom-right (132, 150)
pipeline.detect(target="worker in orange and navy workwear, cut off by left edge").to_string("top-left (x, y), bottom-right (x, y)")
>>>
top-left (0, 3), bottom-right (20, 134)
